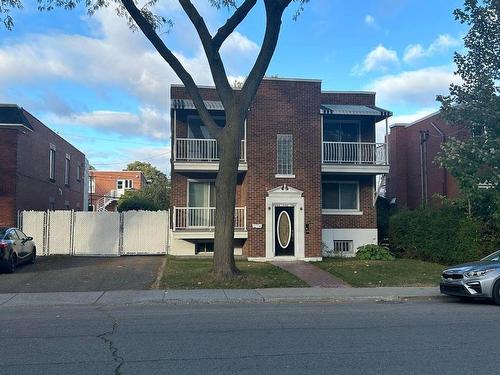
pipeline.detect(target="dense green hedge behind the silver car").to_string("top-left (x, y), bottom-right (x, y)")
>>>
top-left (389, 206), bottom-right (498, 264)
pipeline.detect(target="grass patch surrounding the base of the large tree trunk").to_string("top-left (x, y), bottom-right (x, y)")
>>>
top-left (160, 256), bottom-right (307, 289)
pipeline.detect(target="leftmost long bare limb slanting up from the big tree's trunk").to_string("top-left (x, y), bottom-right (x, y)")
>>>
top-left (121, 0), bottom-right (221, 138)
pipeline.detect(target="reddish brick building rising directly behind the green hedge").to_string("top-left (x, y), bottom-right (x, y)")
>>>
top-left (387, 112), bottom-right (467, 209)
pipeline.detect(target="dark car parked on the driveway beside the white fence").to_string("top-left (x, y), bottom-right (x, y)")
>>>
top-left (0, 228), bottom-right (36, 273)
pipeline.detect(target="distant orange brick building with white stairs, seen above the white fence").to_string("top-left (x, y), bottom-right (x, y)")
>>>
top-left (89, 170), bottom-right (146, 211)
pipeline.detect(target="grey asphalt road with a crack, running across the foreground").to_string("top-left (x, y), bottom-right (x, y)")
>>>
top-left (0, 299), bottom-right (500, 375)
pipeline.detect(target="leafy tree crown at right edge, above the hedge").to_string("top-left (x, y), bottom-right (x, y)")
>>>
top-left (438, 0), bottom-right (500, 210)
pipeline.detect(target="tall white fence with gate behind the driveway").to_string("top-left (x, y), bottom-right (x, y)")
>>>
top-left (19, 211), bottom-right (170, 256)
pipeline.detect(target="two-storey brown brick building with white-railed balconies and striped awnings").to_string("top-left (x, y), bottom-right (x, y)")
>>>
top-left (171, 78), bottom-right (392, 260)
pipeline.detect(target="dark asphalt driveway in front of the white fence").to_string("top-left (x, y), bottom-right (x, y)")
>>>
top-left (0, 256), bottom-right (164, 293)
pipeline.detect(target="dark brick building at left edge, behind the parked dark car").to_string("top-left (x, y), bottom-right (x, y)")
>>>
top-left (0, 104), bottom-right (88, 226)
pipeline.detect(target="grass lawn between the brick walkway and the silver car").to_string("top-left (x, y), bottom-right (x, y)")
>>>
top-left (314, 259), bottom-right (445, 287)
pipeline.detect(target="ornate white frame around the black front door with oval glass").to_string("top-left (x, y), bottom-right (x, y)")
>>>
top-left (266, 185), bottom-right (305, 260)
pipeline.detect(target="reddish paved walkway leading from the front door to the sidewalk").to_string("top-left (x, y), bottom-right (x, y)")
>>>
top-left (271, 260), bottom-right (350, 288)
